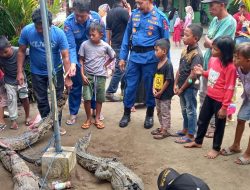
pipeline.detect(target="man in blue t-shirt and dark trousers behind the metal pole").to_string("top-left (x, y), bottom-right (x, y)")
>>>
top-left (17, 8), bottom-right (72, 135)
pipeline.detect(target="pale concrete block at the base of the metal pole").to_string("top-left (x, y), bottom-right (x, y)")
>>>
top-left (42, 147), bottom-right (76, 181)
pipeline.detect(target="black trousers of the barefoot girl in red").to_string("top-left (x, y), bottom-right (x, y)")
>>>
top-left (195, 96), bottom-right (226, 151)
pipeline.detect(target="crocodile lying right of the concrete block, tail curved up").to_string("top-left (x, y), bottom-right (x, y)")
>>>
top-left (75, 133), bottom-right (144, 190)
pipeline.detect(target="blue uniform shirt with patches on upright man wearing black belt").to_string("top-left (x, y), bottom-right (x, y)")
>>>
top-left (120, 7), bottom-right (169, 64)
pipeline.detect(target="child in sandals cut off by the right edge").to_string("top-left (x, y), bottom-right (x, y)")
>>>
top-left (221, 42), bottom-right (250, 165)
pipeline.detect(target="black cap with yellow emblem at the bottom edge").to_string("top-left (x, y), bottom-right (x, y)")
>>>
top-left (158, 168), bottom-right (209, 190)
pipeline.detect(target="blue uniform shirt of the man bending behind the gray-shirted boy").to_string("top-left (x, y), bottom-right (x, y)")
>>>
top-left (64, 11), bottom-right (106, 64)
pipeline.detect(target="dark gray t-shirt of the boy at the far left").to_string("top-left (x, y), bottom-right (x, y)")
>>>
top-left (0, 47), bottom-right (27, 85)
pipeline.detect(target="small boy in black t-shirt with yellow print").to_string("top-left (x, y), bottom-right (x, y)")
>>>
top-left (151, 39), bottom-right (174, 139)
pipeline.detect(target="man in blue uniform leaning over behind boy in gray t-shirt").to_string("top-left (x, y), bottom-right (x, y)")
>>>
top-left (64, 0), bottom-right (106, 125)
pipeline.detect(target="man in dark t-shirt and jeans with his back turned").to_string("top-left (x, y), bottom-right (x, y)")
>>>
top-left (106, 0), bottom-right (130, 101)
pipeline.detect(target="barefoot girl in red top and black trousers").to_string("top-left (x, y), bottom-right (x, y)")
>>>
top-left (184, 36), bottom-right (236, 159)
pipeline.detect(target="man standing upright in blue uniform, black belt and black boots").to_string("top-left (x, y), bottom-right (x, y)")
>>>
top-left (119, 0), bottom-right (169, 129)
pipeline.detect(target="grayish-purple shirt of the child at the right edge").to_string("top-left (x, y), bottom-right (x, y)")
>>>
top-left (237, 68), bottom-right (250, 101)
